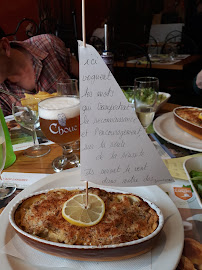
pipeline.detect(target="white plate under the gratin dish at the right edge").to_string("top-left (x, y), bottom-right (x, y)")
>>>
top-left (153, 112), bottom-right (202, 152)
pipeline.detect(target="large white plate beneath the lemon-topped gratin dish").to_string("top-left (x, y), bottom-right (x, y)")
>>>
top-left (0, 169), bottom-right (184, 270)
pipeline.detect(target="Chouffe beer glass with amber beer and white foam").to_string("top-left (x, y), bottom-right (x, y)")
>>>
top-left (38, 95), bottom-right (80, 172)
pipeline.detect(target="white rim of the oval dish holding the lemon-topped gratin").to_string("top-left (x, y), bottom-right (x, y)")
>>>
top-left (9, 186), bottom-right (164, 250)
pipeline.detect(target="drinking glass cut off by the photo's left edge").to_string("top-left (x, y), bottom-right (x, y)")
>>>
top-left (0, 122), bottom-right (16, 200)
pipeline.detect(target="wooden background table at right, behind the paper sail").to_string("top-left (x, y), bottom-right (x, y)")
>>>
top-left (114, 55), bottom-right (202, 71)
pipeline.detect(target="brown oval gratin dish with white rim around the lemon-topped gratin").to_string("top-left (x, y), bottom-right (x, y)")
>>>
top-left (9, 187), bottom-right (164, 261)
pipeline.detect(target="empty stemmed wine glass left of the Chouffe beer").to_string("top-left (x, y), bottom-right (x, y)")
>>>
top-left (12, 98), bottom-right (50, 157)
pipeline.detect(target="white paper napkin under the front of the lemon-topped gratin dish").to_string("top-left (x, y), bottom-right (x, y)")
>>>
top-left (0, 234), bottom-right (152, 270)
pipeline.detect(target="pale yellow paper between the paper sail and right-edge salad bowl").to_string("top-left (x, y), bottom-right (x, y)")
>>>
top-left (163, 153), bottom-right (202, 180)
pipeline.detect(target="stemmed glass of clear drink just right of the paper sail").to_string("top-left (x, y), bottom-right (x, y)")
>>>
top-left (134, 77), bottom-right (159, 129)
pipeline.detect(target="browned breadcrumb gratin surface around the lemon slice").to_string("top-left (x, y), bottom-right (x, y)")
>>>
top-left (14, 188), bottom-right (159, 246)
